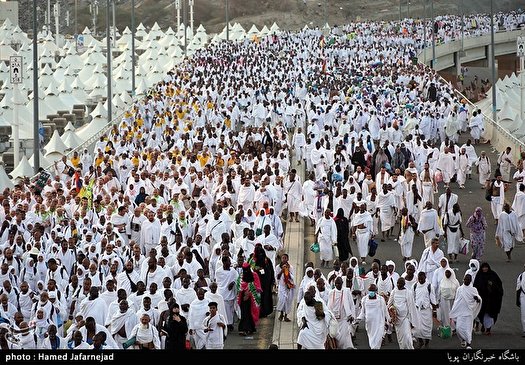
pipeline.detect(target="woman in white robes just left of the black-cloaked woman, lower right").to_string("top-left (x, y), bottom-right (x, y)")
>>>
top-left (449, 274), bottom-right (481, 349)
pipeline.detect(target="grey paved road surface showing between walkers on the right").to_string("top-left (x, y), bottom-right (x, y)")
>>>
top-left (298, 136), bottom-right (525, 349)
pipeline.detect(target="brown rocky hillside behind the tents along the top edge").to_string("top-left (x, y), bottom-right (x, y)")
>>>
top-left (15, 0), bottom-right (525, 34)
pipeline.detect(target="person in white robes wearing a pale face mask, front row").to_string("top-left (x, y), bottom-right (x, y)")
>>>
top-left (357, 284), bottom-right (390, 350)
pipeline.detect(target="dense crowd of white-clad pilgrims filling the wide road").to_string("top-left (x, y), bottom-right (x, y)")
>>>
top-left (0, 9), bottom-right (522, 349)
